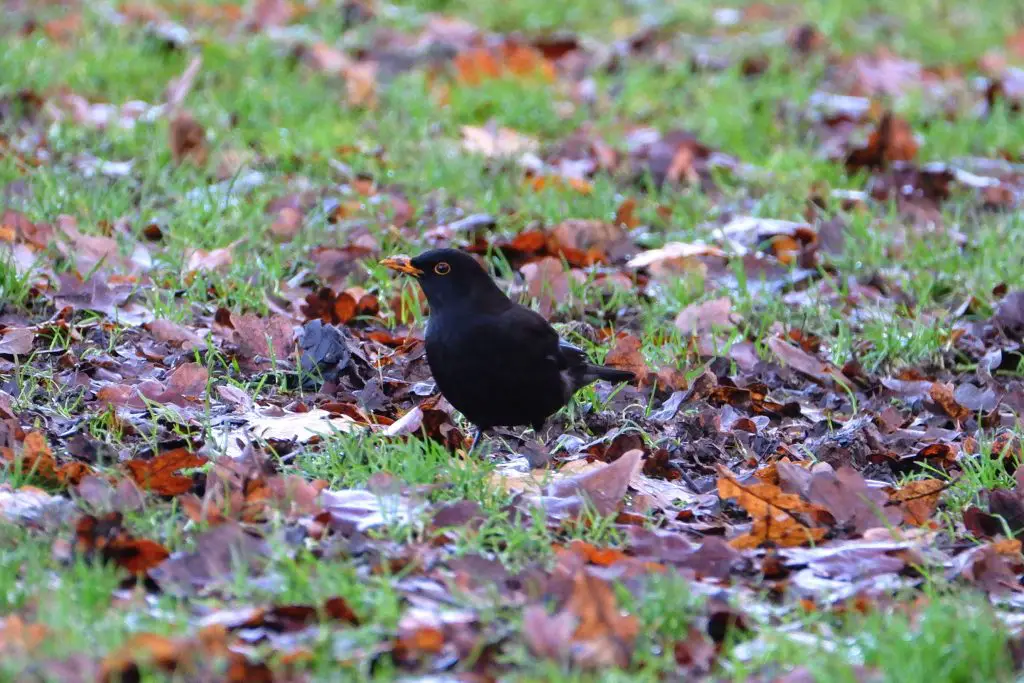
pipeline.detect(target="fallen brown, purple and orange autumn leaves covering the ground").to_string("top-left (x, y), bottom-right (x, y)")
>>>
top-left (6, 0), bottom-right (1024, 681)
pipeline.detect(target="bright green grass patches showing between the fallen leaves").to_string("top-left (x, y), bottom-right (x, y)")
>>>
top-left (0, 0), bottom-right (1024, 681)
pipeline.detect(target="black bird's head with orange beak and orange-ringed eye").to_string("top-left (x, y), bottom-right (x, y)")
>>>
top-left (381, 249), bottom-right (508, 312)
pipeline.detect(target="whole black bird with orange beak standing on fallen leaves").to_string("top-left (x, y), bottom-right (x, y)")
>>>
top-left (381, 249), bottom-right (634, 451)
